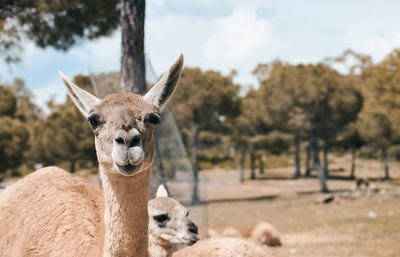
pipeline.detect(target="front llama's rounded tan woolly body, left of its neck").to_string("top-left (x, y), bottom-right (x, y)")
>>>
top-left (0, 167), bottom-right (104, 257)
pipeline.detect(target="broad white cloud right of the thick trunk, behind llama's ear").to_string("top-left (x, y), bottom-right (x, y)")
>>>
top-left (146, 3), bottom-right (285, 84)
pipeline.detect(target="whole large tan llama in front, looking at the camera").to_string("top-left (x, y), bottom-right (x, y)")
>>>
top-left (0, 55), bottom-right (183, 257)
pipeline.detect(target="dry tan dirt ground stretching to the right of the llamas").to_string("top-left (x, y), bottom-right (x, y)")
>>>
top-left (184, 154), bottom-right (400, 257)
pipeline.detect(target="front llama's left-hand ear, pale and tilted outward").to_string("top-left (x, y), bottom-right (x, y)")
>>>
top-left (58, 71), bottom-right (101, 118)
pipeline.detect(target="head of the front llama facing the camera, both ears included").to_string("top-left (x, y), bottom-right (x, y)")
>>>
top-left (59, 55), bottom-right (183, 176)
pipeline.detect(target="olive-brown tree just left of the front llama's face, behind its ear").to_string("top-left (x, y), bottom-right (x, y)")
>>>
top-left (34, 75), bottom-right (96, 173)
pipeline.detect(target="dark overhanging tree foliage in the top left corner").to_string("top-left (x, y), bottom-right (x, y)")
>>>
top-left (0, 0), bottom-right (120, 62)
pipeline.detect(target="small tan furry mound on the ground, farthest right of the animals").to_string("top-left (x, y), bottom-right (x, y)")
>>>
top-left (251, 221), bottom-right (282, 246)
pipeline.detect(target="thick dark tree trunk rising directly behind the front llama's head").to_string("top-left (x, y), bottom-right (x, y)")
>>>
top-left (122, 0), bottom-right (146, 95)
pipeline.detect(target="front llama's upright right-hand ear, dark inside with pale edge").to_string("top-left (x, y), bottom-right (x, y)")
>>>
top-left (144, 54), bottom-right (183, 109)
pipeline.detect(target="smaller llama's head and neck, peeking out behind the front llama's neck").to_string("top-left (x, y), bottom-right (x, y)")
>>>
top-left (148, 185), bottom-right (200, 257)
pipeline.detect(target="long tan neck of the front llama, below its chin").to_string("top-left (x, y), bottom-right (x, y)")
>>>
top-left (100, 165), bottom-right (150, 257)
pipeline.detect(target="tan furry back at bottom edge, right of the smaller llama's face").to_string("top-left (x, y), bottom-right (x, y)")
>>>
top-left (173, 237), bottom-right (277, 257)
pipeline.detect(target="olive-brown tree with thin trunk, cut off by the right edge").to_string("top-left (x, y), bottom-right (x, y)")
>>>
top-left (360, 49), bottom-right (400, 179)
